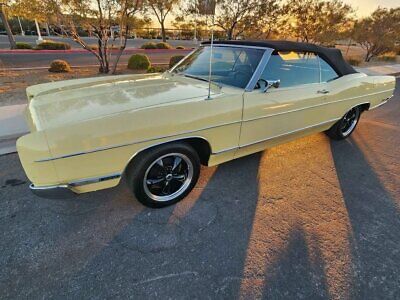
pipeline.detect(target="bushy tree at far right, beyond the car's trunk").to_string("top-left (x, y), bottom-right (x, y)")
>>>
top-left (353, 7), bottom-right (400, 62)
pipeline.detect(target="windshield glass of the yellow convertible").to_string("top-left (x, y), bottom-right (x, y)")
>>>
top-left (173, 46), bottom-right (264, 88)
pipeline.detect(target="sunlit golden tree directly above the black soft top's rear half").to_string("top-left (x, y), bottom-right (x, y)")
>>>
top-left (285, 0), bottom-right (354, 44)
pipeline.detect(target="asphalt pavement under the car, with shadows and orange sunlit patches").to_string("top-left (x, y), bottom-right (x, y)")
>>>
top-left (0, 81), bottom-right (400, 299)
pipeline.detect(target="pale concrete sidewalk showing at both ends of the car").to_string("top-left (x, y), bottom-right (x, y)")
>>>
top-left (0, 64), bottom-right (400, 155)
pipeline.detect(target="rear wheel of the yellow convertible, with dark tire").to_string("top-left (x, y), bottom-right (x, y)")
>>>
top-left (326, 106), bottom-right (361, 140)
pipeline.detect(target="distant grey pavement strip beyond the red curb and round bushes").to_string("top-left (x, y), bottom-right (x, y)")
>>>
top-left (0, 35), bottom-right (196, 49)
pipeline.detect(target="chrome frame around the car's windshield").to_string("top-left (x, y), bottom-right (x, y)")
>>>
top-left (168, 44), bottom-right (274, 92)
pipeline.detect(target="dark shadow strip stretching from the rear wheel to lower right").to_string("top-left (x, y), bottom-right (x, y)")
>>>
top-left (331, 136), bottom-right (400, 299)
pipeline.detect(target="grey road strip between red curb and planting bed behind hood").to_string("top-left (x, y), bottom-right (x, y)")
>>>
top-left (0, 50), bottom-right (191, 69)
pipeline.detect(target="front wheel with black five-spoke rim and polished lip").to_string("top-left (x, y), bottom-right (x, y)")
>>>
top-left (126, 143), bottom-right (200, 208)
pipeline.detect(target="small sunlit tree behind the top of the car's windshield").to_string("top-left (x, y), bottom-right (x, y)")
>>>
top-left (215, 0), bottom-right (260, 40)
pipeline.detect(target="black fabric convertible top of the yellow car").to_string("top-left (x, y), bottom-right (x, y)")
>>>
top-left (202, 40), bottom-right (357, 76)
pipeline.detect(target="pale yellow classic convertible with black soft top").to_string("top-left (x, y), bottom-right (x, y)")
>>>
top-left (17, 41), bottom-right (395, 207)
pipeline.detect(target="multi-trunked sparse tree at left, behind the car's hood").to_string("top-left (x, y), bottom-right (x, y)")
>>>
top-left (13, 0), bottom-right (142, 73)
